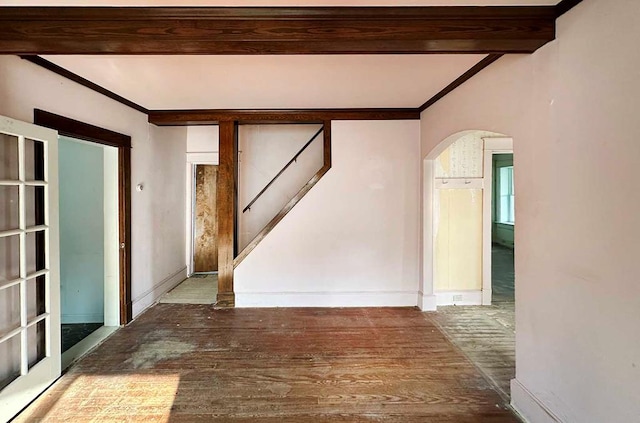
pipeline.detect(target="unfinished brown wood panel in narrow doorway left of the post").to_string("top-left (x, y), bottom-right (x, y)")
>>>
top-left (193, 165), bottom-right (218, 272)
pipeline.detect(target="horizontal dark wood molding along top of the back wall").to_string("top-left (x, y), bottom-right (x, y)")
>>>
top-left (149, 108), bottom-right (420, 126)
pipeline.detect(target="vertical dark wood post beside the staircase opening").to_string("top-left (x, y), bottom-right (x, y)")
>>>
top-left (216, 121), bottom-right (238, 308)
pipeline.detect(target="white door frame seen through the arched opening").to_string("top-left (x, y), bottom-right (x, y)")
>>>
top-left (482, 137), bottom-right (513, 305)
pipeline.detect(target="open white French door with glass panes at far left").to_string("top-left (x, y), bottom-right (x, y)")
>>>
top-left (0, 116), bottom-right (60, 422)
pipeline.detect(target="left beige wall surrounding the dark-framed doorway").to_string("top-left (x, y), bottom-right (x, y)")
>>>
top-left (0, 56), bottom-right (186, 315)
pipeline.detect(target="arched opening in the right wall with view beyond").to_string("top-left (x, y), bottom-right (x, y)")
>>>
top-left (421, 130), bottom-right (515, 397)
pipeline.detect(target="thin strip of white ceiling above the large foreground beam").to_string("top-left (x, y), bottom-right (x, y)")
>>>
top-left (0, 0), bottom-right (560, 7)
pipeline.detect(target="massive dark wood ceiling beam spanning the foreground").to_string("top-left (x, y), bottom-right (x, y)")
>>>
top-left (0, 6), bottom-right (556, 55)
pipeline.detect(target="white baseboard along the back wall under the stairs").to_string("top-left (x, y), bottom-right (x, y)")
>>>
top-left (236, 291), bottom-right (417, 307)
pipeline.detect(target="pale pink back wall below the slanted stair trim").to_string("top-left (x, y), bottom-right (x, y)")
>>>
top-left (235, 121), bottom-right (420, 306)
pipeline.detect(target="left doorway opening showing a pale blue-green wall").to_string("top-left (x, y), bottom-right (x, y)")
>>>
top-left (58, 136), bottom-right (120, 368)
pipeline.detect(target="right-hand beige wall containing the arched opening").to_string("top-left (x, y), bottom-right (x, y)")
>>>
top-left (421, 0), bottom-right (640, 423)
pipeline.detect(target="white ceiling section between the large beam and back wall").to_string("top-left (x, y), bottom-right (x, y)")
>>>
top-left (43, 54), bottom-right (484, 109)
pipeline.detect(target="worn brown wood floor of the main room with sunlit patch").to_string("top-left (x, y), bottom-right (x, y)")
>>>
top-left (17, 304), bottom-right (518, 423)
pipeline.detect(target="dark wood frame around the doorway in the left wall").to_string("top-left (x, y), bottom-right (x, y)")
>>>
top-left (33, 109), bottom-right (133, 325)
